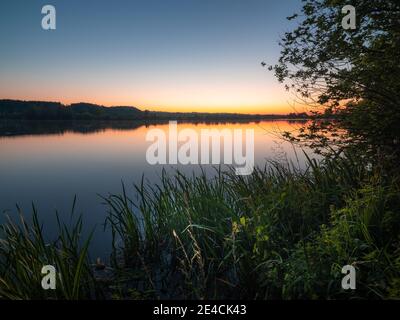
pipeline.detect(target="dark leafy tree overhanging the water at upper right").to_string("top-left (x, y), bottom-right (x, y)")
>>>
top-left (270, 0), bottom-right (400, 170)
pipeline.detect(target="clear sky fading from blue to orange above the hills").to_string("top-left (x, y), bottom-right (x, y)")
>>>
top-left (0, 0), bottom-right (301, 113)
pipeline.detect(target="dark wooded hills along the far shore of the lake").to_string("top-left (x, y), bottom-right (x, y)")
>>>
top-left (0, 100), bottom-right (308, 121)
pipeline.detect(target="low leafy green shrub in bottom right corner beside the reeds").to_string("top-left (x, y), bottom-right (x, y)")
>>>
top-left (284, 182), bottom-right (400, 298)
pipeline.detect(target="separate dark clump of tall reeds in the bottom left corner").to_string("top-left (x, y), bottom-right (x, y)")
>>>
top-left (0, 200), bottom-right (99, 300)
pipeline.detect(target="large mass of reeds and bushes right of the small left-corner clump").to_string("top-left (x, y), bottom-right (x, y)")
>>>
top-left (102, 157), bottom-right (400, 299)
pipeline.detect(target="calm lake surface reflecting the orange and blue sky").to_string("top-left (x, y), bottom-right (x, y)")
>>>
top-left (0, 121), bottom-right (316, 257)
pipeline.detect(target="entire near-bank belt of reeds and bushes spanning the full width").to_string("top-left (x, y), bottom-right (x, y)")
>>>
top-left (0, 156), bottom-right (400, 299)
